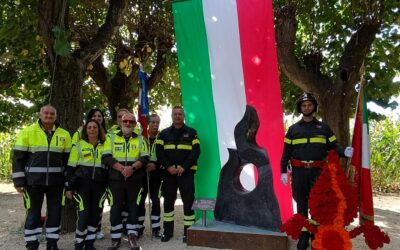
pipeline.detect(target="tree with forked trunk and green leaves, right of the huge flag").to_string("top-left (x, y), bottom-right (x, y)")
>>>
top-left (274, 0), bottom-right (400, 145)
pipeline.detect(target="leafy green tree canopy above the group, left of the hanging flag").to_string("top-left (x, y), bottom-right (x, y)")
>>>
top-left (0, 0), bottom-right (180, 131)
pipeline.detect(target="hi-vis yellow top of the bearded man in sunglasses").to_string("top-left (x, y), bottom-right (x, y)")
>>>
top-left (102, 131), bottom-right (149, 181)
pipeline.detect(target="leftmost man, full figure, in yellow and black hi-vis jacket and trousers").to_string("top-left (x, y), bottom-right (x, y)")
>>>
top-left (12, 105), bottom-right (71, 250)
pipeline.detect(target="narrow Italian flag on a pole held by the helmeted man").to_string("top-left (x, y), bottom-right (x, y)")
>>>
top-left (351, 84), bottom-right (374, 225)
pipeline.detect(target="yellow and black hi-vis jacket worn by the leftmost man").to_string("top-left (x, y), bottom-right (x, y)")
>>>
top-left (12, 121), bottom-right (71, 187)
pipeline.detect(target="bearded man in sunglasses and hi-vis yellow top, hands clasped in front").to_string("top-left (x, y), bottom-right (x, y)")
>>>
top-left (103, 113), bottom-right (148, 250)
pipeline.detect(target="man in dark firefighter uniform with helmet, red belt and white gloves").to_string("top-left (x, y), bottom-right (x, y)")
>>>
top-left (281, 93), bottom-right (353, 249)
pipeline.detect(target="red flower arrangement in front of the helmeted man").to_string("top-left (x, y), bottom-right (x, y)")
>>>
top-left (281, 151), bottom-right (390, 250)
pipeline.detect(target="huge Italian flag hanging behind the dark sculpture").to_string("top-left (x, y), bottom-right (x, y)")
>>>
top-left (173, 0), bottom-right (293, 221)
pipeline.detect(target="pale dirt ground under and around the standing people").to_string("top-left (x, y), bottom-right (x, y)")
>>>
top-left (0, 183), bottom-right (400, 250)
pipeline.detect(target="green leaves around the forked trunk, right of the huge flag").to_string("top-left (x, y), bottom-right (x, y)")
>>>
top-left (275, 0), bottom-right (400, 112)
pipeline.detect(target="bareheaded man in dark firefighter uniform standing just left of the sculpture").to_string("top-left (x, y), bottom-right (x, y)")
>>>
top-left (156, 106), bottom-right (200, 242)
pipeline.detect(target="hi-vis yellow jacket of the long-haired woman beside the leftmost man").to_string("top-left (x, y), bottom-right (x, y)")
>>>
top-left (65, 139), bottom-right (108, 190)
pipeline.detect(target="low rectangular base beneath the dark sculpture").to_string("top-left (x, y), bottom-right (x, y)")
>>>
top-left (187, 220), bottom-right (289, 250)
